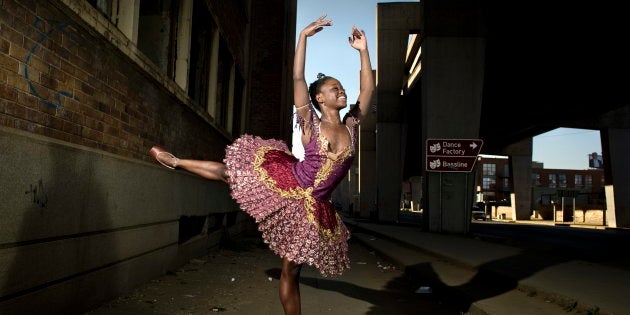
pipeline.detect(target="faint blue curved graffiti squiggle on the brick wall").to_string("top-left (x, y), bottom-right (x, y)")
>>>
top-left (24, 17), bottom-right (79, 109)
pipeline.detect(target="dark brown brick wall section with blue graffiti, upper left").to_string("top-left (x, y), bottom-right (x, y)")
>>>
top-left (0, 1), bottom-right (230, 161)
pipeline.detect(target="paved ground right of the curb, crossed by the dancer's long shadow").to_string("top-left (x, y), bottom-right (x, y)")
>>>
top-left (348, 220), bottom-right (630, 315)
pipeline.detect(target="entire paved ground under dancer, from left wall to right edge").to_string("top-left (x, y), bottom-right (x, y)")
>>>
top-left (87, 222), bottom-right (630, 315)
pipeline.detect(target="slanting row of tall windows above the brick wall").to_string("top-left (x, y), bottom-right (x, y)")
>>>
top-left (87, 0), bottom-right (239, 134)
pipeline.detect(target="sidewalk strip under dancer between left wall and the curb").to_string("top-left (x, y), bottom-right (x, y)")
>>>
top-left (86, 238), bottom-right (462, 315)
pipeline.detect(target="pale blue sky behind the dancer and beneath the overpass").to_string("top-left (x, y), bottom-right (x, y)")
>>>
top-left (293, 0), bottom-right (602, 170)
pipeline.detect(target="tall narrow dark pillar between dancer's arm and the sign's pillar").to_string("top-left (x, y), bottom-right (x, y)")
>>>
top-left (376, 3), bottom-right (421, 222)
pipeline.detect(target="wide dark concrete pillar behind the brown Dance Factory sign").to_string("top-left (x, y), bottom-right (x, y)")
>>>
top-left (421, 37), bottom-right (485, 233)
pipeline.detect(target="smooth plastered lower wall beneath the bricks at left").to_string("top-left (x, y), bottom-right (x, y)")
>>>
top-left (0, 128), bottom-right (242, 314)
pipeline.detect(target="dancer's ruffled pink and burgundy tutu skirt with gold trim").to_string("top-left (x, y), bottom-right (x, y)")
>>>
top-left (224, 135), bottom-right (350, 277)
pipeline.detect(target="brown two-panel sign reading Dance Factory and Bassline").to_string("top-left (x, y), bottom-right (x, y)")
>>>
top-left (426, 139), bottom-right (483, 172)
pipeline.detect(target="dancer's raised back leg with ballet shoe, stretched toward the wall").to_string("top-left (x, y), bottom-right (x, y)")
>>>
top-left (149, 146), bottom-right (227, 182)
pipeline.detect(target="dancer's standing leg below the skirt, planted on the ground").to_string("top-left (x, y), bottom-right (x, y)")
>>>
top-left (280, 257), bottom-right (302, 315)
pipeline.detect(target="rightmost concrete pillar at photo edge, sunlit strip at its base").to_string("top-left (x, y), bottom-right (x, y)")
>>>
top-left (600, 128), bottom-right (630, 228)
